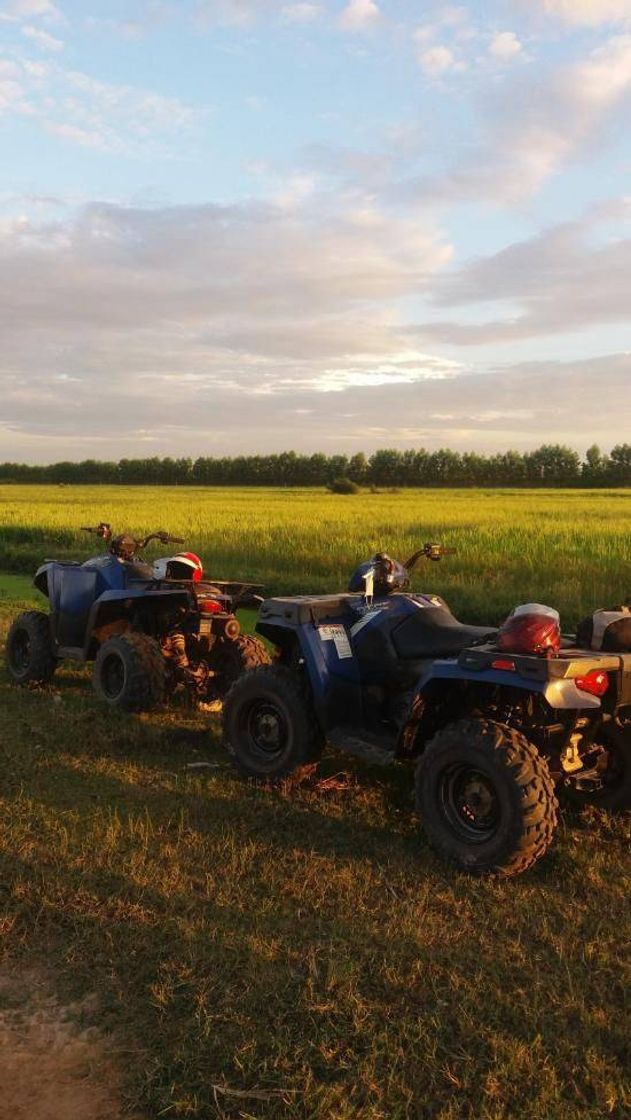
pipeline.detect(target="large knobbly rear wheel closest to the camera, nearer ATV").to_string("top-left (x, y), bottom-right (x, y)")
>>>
top-left (416, 719), bottom-right (558, 878)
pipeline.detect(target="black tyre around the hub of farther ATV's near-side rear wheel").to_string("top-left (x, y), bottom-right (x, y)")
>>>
top-left (92, 631), bottom-right (167, 711)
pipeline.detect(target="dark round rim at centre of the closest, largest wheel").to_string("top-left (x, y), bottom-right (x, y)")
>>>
top-left (438, 763), bottom-right (501, 843)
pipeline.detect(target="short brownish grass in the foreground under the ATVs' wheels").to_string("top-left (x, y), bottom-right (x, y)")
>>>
top-left (0, 604), bottom-right (629, 1120)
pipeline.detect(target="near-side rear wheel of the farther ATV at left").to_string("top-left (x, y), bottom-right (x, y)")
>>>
top-left (92, 631), bottom-right (167, 711)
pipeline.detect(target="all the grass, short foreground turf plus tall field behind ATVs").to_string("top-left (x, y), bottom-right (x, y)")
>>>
top-left (0, 487), bottom-right (631, 1120)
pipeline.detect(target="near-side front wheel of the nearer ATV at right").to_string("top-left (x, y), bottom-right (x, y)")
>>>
top-left (223, 665), bottom-right (324, 778)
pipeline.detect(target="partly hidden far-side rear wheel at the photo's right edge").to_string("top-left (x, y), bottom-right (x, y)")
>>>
top-left (559, 726), bottom-right (631, 812)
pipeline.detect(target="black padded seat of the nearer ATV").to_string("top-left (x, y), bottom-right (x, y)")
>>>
top-left (392, 607), bottom-right (498, 661)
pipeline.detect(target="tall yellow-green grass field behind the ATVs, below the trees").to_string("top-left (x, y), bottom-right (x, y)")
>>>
top-left (0, 485), bottom-right (631, 627)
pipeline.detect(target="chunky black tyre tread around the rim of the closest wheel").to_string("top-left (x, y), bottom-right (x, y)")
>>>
top-left (416, 719), bottom-right (558, 878)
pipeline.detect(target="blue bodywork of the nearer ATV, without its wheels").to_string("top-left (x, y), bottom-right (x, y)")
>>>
top-left (257, 594), bottom-right (631, 763)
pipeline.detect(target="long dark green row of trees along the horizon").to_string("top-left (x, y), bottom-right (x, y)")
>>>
top-left (0, 444), bottom-right (631, 487)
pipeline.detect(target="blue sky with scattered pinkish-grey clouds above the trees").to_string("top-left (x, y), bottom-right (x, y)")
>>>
top-left (0, 0), bottom-right (631, 463)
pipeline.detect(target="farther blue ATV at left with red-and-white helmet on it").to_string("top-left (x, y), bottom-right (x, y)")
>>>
top-left (6, 522), bottom-right (270, 711)
